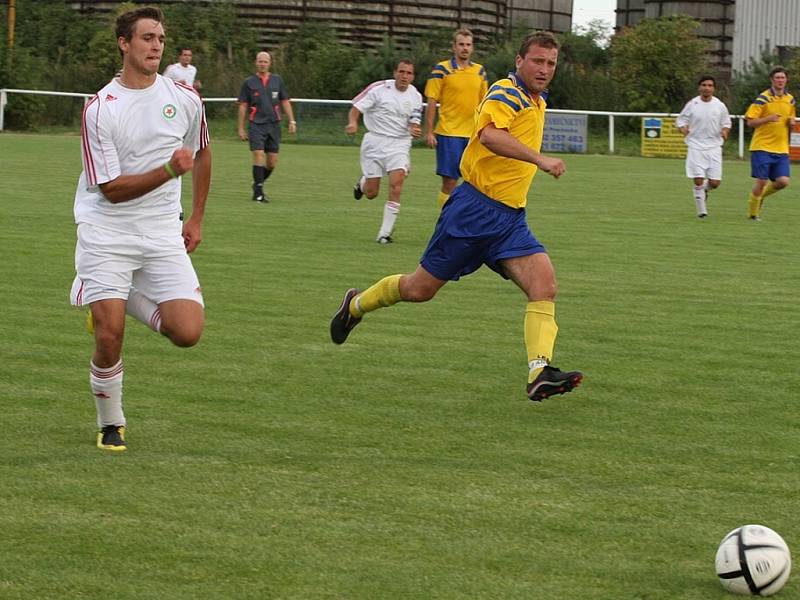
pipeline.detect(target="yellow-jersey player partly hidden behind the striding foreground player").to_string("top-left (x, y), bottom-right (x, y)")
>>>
top-left (425, 29), bottom-right (488, 207)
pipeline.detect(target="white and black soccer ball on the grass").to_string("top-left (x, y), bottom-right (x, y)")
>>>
top-left (714, 525), bottom-right (792, 596)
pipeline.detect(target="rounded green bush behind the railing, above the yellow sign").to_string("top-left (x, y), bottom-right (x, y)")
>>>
top-left (611, 15), bottom-right (707, 112)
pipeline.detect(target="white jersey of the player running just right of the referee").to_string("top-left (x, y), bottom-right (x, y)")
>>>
top-left (353, 79), bottom-right (422, 139)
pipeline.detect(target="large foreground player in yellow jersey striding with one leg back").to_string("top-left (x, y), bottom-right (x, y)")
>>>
top-left (331, 32), bottom-right (583, 400)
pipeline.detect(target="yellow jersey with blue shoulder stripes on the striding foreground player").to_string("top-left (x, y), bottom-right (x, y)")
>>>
top-left (461, 76), bottom-right (547, 208)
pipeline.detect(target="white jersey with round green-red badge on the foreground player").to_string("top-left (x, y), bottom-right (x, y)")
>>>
top-left (74, 75), bottom-right (209, 233)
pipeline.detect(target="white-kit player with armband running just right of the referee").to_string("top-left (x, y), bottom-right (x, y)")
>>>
top-left (345, 59), bottom-right (422, 244)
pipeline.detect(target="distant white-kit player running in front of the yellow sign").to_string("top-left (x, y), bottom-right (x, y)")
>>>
top-left (675, 75), bottom-right (731, 219)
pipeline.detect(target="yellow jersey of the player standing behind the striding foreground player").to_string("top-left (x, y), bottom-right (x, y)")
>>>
top-left (425, 57), bottom-right (488, 137)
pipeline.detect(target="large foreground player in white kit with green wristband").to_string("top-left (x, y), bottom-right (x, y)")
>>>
top-left (70, 7), bottom-right (211, 451)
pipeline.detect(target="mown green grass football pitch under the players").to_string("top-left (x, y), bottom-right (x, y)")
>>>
top-left (0, 131), bottom-right (800, 600)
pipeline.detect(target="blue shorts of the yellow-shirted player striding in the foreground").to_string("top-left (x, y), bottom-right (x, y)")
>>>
top-left (419, 182), bottom-right (546, 281)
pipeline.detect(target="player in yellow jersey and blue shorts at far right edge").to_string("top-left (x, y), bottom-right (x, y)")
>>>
top-left (744, 66), bottom-right (797, 221)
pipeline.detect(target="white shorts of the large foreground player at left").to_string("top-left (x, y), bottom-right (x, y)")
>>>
top-left (70, 223), bottom-right (204, 306)
